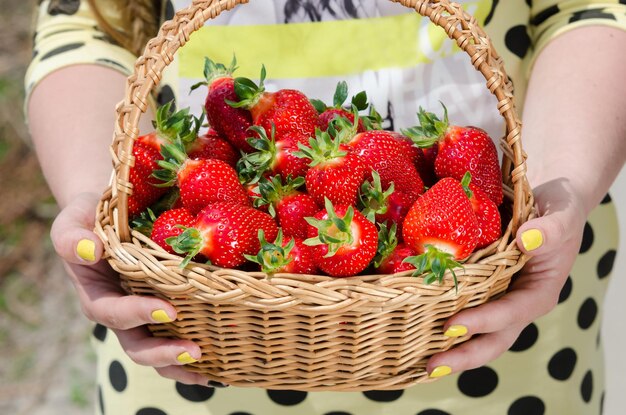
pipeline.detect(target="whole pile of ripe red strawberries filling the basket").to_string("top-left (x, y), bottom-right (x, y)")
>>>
top-left (128, 59), bottom-right (503, 283)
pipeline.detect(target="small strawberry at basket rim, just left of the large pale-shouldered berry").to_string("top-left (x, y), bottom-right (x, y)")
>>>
top-left (374, 223), bottom-right (415, 274)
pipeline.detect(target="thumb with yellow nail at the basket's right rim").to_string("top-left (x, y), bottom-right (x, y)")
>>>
top-left (516, 209), bottom-right (584, 256)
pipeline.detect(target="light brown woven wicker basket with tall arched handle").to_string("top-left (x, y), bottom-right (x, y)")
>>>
top-left (96, 0), bottom-right (534, 391)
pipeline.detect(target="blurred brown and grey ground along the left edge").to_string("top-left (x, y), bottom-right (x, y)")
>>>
top-left (0, 0), bottom-right (95, 415)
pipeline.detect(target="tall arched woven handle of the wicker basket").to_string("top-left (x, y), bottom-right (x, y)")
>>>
top-left (108, 0), bottom-right (532, 242)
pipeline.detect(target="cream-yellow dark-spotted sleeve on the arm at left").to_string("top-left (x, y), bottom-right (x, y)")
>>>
top-left (24, 0), bottom-right (136, 108)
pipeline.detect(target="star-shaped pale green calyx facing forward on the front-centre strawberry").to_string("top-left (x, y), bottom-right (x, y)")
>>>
top-left (304, 198), bottom-right (354, 258)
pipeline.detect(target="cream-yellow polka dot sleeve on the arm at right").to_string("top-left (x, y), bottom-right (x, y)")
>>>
top-left (530, 0), bottom-right (626, 66)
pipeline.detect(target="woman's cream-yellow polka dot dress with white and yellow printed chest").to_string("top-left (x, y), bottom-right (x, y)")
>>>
top-left (25, 0), bottom-right (626, 415)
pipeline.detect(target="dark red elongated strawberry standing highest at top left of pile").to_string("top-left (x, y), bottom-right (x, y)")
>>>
top-left (191, 56), bottom-right (252, 152)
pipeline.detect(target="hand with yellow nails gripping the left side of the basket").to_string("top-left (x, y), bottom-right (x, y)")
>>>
top-left (51, 193), bottom-right (209, 386)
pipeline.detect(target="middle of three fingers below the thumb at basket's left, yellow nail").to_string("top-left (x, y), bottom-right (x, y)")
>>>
top-left (115, 327), bottom-right (202, 368)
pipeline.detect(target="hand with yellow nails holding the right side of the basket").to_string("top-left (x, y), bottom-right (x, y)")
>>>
top-left (427, 179), bottom-right (586, 377)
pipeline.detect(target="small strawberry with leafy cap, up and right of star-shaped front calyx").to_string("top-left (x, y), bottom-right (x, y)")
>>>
top-left (359, 171), bottom-right (412, 235)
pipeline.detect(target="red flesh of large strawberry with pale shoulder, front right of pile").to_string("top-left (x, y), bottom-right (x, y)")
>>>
top-left (402, 177), bottom-right (479, 260)
